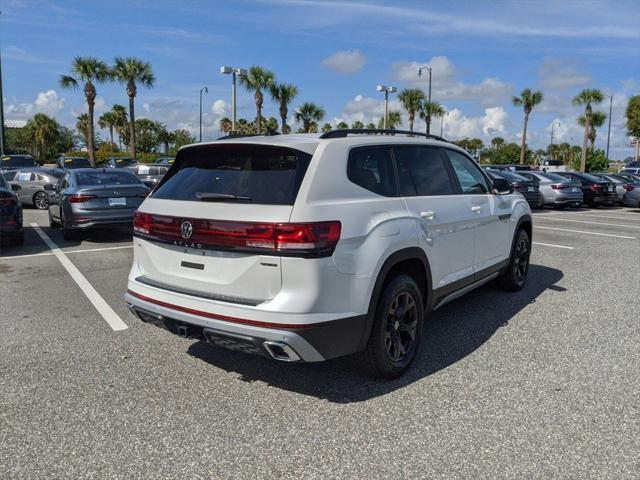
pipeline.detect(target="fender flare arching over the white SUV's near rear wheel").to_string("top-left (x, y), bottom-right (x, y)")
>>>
top-left (358, 247), bottom-right (433, 351)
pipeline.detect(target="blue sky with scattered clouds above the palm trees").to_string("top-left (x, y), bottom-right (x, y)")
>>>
top-left (0, 0), bottom-right (640, 157)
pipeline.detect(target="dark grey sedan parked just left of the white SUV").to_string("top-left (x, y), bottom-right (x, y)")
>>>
top-left (47, 168), bottom-right (150, 240)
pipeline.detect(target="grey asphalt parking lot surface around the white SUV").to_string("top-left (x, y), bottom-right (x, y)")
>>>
top-left (0, 208), bottom-right (640, 479)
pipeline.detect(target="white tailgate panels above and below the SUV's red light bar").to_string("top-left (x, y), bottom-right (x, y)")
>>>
top-left (134, 198), bottom-right (292, 304)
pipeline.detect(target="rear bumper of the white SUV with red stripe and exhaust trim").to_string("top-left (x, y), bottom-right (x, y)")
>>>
top-left (125, 289), bottom-right (366, 362)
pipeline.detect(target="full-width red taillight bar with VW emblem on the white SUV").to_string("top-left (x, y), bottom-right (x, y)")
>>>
top-left (133, 211), bottom-right (342, 257)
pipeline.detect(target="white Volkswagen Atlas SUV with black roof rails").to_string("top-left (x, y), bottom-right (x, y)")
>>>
top-left (125, 130), bottom-right (532, 378)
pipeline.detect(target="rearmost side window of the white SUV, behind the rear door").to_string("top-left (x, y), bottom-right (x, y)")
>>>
top-left (347, 147), bottom-right (398, 197)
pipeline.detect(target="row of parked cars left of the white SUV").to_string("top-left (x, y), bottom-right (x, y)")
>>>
top-left (0, 155), bottom-right (173, 245)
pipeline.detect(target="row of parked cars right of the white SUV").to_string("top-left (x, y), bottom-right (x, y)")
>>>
top-left (485, 165), bottom-right (640, 209)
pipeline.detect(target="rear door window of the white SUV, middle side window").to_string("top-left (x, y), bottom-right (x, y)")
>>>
top-left (393, 147), bottom-right (457, 196)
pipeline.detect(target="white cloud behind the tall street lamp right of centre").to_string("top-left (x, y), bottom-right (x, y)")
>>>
top-left (391, 56), bottom-right (512, 107)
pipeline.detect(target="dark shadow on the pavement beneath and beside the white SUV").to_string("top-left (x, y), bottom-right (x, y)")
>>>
top-left (188, 265), bottom-right (566, 403)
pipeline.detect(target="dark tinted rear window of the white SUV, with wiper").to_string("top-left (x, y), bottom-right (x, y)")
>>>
top-left (153, 144), bottom-right (311, 205)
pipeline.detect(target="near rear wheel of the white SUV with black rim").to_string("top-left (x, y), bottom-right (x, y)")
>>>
top-left (358, 274), bottom-right (424, 379)
